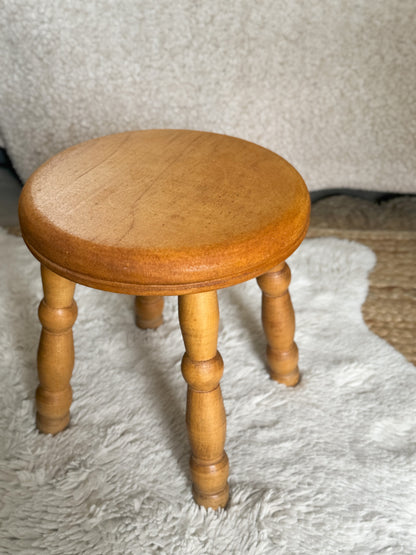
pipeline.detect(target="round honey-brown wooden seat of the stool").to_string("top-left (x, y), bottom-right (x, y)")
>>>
top-left (19, 130), bottom-right (310, 295)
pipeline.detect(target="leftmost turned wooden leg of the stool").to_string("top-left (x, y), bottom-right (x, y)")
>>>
top-left (36, 266), bottom-right (77, 434)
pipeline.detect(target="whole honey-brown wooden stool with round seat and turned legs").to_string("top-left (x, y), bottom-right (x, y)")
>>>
top-left (19, 130), bottom-right (310, 509)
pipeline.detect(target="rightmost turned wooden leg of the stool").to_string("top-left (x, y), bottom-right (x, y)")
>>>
top-left (257, 262), bottom-right (300, 385)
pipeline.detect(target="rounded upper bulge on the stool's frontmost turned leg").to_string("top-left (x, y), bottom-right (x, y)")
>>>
top-left (181, 351), bottom-right (224, 392)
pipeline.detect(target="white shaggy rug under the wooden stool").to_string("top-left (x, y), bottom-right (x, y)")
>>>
top-left (0, 230), bottom-right (416, 555)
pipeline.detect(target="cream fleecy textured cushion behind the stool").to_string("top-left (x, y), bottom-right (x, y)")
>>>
top-left (0, 0), bottom-right (416, 192)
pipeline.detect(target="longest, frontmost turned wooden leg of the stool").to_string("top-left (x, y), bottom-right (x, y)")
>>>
top-left (179, 291), bottom-right (229, 509)
